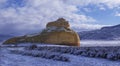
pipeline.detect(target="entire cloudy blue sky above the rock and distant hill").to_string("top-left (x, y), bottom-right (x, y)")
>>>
top-left (0, 0), bottom-right (120, 35)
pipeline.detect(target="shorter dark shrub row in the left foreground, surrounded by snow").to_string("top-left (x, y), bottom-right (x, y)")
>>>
top-left (10, 50), bottom-right (70, 62)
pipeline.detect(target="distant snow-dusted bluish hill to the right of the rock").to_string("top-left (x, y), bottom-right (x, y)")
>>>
top-left (78, 24), bottom-right (120, 40)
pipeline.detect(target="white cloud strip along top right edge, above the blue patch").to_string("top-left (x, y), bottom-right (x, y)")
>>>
top-left (65, 0), bottom-right (120, 8)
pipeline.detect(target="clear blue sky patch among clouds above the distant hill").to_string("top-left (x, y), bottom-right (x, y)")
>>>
top-left (83, 5), bottom-right (120, 25)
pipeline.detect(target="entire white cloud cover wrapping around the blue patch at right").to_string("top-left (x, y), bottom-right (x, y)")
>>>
top-left (0, 0), bottom-right (120, 33)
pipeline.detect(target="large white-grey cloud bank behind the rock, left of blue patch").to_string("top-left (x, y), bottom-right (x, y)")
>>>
top-left (0, 0), bottom-right (95, 32)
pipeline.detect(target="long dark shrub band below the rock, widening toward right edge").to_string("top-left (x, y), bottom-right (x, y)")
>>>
top-left (26, 46), bottom-right (120, 60)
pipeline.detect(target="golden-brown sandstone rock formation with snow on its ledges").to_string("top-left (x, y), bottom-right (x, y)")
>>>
top-left (4, 18), bottom-right (80, 46)
